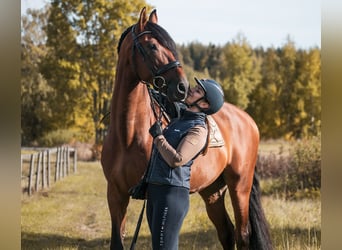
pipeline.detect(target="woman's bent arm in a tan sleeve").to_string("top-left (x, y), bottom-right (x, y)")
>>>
top-left (154, 126), bottom-right (207, 167)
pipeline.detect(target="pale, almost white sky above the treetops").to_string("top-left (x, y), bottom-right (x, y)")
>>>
top-left (21, 0), bottom-right (321, 49)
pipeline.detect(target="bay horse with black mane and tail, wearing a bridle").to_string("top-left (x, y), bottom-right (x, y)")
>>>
top-left (101, 8), bottom-right (272, 250)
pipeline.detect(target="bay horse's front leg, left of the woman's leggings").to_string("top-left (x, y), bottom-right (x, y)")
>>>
top-left (107, 183), bottom-right (129, 250)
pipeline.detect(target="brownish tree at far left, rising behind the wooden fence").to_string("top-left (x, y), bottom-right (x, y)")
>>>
top-left (21, 8), bottom-right (53, 145)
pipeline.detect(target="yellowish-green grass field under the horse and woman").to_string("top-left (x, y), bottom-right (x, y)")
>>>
top-left (21, 162), bottom-right (321, 250)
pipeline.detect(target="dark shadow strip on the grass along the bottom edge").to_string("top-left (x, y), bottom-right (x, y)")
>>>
top-left (21, 228), bottom-right (321, 250)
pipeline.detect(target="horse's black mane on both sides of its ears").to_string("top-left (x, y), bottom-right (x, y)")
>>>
top-left (117, 22), bottom-right (178, 60)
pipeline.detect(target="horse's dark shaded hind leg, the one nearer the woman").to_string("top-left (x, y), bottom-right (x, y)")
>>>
top-left (200, 177), bottom-right (235, 250)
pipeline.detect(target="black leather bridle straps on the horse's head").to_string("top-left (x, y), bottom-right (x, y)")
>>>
top-left (132, 25), bottom-right (181, 89)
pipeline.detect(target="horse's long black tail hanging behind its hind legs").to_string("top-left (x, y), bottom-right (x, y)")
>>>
top-left (249, 174), bottom-right (273, 250)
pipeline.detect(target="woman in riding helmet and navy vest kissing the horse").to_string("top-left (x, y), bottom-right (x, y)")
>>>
top-left (146, 78), bottom-right (224, 250)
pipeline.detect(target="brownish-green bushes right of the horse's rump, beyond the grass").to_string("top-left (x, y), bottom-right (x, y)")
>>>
top-left (257, 137), bottom-right (321, 198)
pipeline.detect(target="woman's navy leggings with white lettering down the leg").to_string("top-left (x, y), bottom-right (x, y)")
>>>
top-left (146, 183), bottom-right (189, 250)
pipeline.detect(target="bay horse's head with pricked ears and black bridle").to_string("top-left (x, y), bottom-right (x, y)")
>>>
top-left (131, 8), bottom-right (189, 101)
